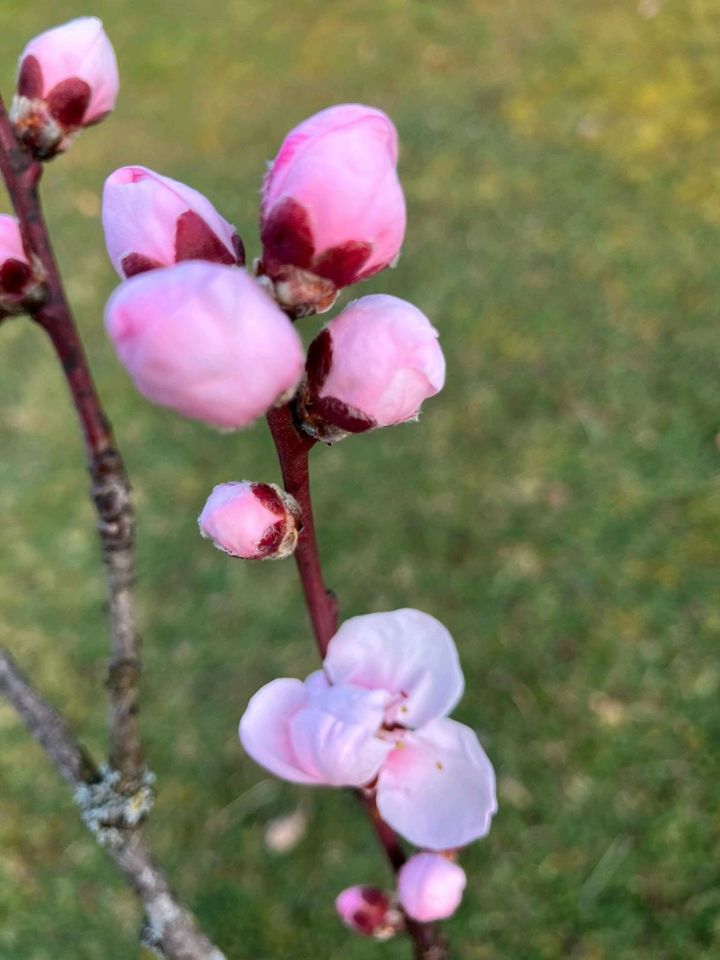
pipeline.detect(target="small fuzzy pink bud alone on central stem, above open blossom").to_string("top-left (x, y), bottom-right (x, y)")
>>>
top-left (198, 480), bottom-right (301, 560)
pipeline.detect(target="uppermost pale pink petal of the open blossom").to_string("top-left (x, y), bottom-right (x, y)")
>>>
top-left (325, 609), bottom-right (464, 727)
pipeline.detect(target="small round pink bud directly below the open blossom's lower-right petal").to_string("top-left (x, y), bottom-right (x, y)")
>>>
top-left (398, 853), bottom-right (467, 923)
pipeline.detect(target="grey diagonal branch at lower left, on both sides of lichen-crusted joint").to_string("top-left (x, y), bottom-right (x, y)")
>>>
top-left (0, 647), bottom-right (225, 960)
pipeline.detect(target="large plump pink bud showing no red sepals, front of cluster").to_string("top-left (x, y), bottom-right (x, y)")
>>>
top-left (105, 260), bottom-right (303, 429)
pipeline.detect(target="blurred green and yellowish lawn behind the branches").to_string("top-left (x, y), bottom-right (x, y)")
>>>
top-left (0, 0), bottom-right (720, 960)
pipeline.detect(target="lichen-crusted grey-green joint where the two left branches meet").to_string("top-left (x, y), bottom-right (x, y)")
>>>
top-left (73, 764), bottom-right (155, 847)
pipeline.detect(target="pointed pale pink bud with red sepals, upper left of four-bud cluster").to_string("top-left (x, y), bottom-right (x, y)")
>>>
top-left (103, 167), bottom-right (245, 277)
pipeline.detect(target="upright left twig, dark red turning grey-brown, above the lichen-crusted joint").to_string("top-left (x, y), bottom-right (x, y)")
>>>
top-left (0, 97), bottom-right (144, 794)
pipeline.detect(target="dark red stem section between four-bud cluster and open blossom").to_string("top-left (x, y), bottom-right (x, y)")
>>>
top-left (267, 404), bottom-right (338, 659)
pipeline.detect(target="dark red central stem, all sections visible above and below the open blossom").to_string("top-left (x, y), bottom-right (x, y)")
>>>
top-left (267, 404), bottom-right (448, 960)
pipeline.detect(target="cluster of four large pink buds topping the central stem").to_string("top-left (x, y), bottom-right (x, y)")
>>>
top-left (103, 104), bottom-right (445, 441)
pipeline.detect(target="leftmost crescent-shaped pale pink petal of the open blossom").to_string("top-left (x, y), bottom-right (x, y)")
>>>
top-left (240, 678), bottom-right (322, 783)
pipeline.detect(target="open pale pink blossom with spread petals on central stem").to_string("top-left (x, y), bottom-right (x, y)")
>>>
top-left (240, 610), bottom-right (496, 850)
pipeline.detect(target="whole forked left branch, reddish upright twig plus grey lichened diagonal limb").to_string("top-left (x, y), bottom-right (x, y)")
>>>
top-left (0, 97), bottom-right (225, 960)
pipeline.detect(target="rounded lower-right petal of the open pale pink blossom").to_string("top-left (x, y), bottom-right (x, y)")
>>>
top-left (377, 718), bottom-right (497, 850)
